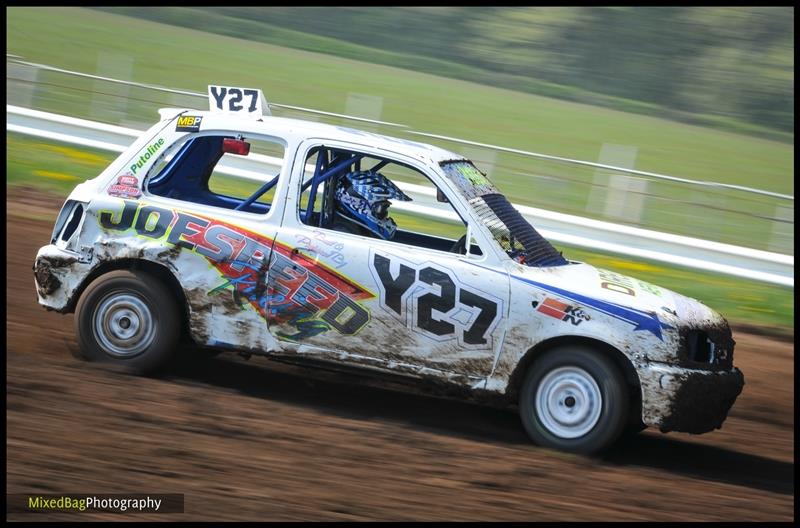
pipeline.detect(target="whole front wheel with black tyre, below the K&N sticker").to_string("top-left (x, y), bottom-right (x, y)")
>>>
top-left (519, 346), bottom-right (629, 454)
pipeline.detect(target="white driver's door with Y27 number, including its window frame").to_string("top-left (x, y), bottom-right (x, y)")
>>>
top-left (268, 142), bottom-right (509, 378)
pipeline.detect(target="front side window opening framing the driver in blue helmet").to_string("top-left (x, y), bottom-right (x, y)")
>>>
top-left (298, 146), bottom-right (481, 254)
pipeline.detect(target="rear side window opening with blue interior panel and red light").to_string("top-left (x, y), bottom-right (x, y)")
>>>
top-left (147, 135), bottom-right (285, 214)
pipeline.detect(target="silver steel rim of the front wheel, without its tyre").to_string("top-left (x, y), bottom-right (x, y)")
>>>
top-left (535, 367), bottom-right (603, 438)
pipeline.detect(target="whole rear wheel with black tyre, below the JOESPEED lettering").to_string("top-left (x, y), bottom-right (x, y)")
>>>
top-left (75, 270), bottom-right (181, 373)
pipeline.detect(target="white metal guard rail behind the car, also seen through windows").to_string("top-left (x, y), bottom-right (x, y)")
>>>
top-left (6, 105), bottom-right (794, 287)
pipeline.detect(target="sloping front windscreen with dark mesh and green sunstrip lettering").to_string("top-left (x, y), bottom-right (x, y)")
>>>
top-left (441, 160), bottom-right (568, 267)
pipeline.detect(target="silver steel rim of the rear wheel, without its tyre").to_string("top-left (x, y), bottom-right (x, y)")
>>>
top-left (93, 292), bottom-right (156, 358)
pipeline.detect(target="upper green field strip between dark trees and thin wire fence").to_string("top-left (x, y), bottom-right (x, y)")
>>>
top-left (6, 8), bottom-right (793, 192)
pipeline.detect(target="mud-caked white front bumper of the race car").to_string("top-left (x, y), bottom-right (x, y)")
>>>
top-left (639, 362), bottom-right (744, 434)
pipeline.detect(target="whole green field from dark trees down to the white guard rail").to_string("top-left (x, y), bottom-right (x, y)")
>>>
top-left (6, 8), bottom-right (794, 253)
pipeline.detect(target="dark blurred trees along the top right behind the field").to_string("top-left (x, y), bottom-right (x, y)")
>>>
top-left (97, 6), bottom-right (794, 141)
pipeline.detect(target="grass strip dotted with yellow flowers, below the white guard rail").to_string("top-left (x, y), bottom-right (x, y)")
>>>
top-left (6, 134), bottom-right (794, 330)
